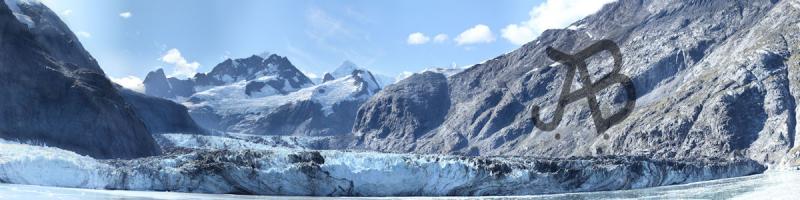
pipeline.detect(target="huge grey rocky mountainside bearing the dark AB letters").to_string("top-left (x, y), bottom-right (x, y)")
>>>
top-left (354, 0), bottom-right (800, 164)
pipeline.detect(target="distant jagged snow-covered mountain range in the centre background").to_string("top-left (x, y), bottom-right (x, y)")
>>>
top-left (144, 54), bottom-right (381, 138)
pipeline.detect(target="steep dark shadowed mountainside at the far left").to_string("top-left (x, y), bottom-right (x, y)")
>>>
top-left (0, 3), bottom-right (160, 158)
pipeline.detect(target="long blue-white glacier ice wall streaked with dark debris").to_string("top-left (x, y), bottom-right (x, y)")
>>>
top-left (0, 135), bottom-right (764, 196)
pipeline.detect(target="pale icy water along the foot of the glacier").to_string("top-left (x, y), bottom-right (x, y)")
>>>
top-left (0, 171), bottom-right (800, 200)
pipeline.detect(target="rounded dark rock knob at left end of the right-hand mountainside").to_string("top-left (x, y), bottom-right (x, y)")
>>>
top-left (353, 72), bottom-right (450, 150)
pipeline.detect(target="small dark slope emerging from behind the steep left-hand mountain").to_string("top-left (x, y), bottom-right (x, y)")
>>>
top-left (118, 87), bottom-right (208, 134)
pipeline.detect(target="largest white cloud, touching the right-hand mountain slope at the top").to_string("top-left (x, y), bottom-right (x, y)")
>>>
top-left (501, 0), bottom-right (615, 45)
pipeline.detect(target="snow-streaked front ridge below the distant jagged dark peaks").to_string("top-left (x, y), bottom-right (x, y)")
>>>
top-left (184, 66), bottom-right (380, 136)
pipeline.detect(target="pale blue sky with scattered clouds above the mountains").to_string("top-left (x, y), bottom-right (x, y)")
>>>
top-left (36, 0), bottom-right (607, 86)
